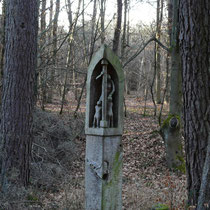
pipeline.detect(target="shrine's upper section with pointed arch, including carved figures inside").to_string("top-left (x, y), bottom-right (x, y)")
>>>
top-left (85, 44), bottom-right (124, 136)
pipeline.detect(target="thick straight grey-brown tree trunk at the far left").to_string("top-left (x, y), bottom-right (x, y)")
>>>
top-left (1, 0), bottom-right (38, 190)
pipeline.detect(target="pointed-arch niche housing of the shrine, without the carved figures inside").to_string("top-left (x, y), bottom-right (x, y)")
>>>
top-left (85, 45), bottom-right (124, 135)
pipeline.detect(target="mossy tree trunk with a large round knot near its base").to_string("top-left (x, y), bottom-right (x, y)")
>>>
top-left (160, 0), bottom-right (185, 172)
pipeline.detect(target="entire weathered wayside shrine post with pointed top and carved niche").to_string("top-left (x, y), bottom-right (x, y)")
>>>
top-left (85, 45), bottom-right (124, 210)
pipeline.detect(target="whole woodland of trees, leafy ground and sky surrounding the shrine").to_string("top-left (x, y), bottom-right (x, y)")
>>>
top-left (0, 0), bottom-right (210, 209)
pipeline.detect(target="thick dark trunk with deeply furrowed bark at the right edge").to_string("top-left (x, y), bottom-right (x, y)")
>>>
top-left (179, 0), bottom-right (210, 209)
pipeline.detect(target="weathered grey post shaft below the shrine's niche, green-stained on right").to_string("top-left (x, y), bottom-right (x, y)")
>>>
top-left (85, 135), bottom-right (122, 210)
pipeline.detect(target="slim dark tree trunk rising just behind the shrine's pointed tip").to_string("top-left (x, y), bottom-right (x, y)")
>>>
top-left (113, 0), bottom-right (122, 54)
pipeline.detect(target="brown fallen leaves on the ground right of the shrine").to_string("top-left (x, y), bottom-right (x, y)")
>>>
top-left (123, 97), bottom-right (186, 210)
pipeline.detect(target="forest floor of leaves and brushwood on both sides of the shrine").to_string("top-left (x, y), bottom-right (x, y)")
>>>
top-left (0, 92), bottom-right (186, 210)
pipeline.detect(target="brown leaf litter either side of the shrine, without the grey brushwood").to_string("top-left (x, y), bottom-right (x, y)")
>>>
top-left (28, 98), bottom-right (186, 210)
